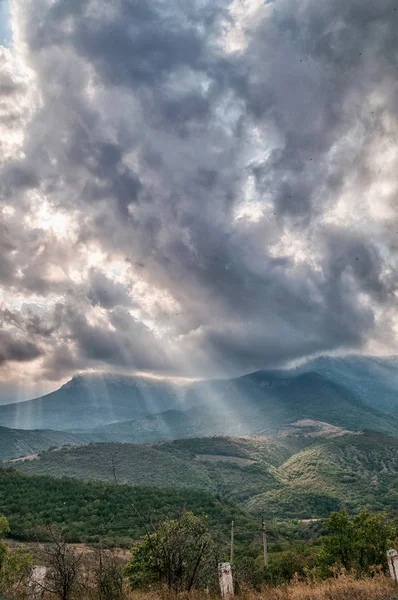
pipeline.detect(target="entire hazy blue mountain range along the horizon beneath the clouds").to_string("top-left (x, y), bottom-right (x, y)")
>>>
top-left (0, 356), bottom-right (398, 442)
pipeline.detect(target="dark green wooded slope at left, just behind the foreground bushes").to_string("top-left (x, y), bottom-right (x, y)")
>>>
top-left (0, 470), bottom-right (262, 548)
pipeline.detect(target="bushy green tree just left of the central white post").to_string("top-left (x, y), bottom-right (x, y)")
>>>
top-left (127, 512), bottom-right (217, 593)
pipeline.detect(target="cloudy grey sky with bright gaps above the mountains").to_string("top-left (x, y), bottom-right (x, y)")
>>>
top-left (0, 0), bottom-right (398, 402)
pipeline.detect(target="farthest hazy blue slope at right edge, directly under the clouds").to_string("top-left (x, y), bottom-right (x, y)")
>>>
top-left (295, 356), bottom-right (398, 414)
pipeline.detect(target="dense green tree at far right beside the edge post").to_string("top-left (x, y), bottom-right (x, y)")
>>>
top-left (320, 510), bottom-right (397, 573)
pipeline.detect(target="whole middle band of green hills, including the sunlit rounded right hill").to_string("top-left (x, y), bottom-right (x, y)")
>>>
top-left (8, 420), bottom-right (398, 520)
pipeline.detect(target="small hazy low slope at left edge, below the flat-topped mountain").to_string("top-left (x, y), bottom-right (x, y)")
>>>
top-left (0, 427), bottom-right (81, 460)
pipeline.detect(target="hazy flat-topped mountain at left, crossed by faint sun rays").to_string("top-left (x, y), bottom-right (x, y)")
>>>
top-left (0, 374), bottom-right (178, 430)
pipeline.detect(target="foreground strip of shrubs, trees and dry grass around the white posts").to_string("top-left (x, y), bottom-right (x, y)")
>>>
top-left (0, 511), bottom-right (398, 600)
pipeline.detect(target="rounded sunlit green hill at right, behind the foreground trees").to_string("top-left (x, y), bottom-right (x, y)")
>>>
top-left (247, 432), bottom-right (398, 518)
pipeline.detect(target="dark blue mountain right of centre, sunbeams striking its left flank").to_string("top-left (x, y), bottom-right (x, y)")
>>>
top-left (84, 371), bottom-right (398, 442)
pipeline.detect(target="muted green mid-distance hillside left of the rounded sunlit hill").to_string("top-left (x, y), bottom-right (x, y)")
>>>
top-left (3, 436), bottom-right (309, 503)
